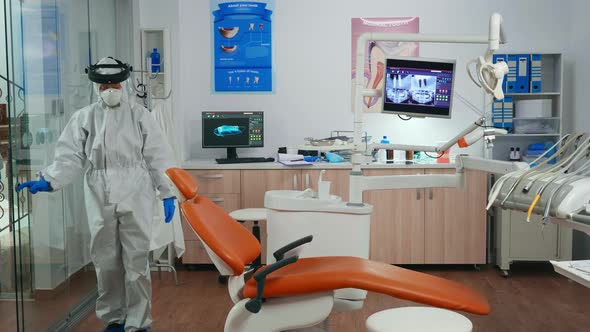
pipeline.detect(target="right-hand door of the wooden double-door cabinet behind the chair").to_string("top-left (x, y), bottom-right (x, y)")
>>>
top-left (424, 169), bottom-right (487, 264)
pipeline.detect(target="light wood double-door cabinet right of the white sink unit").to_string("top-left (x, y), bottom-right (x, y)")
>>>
top-left (363, 169), bottom-right (487, 264)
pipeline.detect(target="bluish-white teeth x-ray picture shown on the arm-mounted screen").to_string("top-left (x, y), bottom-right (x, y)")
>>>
top-left (385, 73), bottom-right (436, 106)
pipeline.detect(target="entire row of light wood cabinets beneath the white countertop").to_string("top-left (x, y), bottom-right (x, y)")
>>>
top-left (183, 168), bottom-right (487, 264)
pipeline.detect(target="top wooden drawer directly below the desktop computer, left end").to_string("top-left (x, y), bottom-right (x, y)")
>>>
top-left (188, 170), bottom-right (240, 194)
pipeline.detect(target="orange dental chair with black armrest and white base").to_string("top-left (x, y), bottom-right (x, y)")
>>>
top-left (166, 168), bottom-right (490, 332)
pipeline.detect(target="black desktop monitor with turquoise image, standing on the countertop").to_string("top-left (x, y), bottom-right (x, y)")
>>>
top-left (202, 111), bottom-right (264, 159)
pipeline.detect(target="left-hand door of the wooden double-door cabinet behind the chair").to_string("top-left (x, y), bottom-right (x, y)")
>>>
top-left (363, 169), bottom-right (424, 264)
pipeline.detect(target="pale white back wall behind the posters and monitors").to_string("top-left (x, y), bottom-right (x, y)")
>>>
top-left (139, 0), bottom-right (571, 160)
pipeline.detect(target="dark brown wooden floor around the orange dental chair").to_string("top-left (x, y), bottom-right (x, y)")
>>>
top-left (76, 264), bottom-right (590, 332)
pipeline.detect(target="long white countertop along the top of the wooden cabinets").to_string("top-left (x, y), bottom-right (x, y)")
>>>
top-left (181, 160), bottom-right (455, 169)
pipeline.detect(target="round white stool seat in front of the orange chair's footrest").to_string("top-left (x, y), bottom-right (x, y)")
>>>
top-left (366, 307), bottom-right (473, 332)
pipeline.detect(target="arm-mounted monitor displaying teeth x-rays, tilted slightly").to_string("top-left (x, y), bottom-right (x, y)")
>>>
top-left (383, 57), bottom-right (455, 118)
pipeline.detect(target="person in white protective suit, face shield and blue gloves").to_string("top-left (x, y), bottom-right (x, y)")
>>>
top-left (17, 57), bottom-right (175, 332)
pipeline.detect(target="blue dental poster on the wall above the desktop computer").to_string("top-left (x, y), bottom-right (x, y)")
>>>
top-left (211, 0), bottom-right (274, 92)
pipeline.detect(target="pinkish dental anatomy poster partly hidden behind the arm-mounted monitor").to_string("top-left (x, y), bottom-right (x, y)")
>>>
top-left (351, 17), bottom-right (420, 112)
